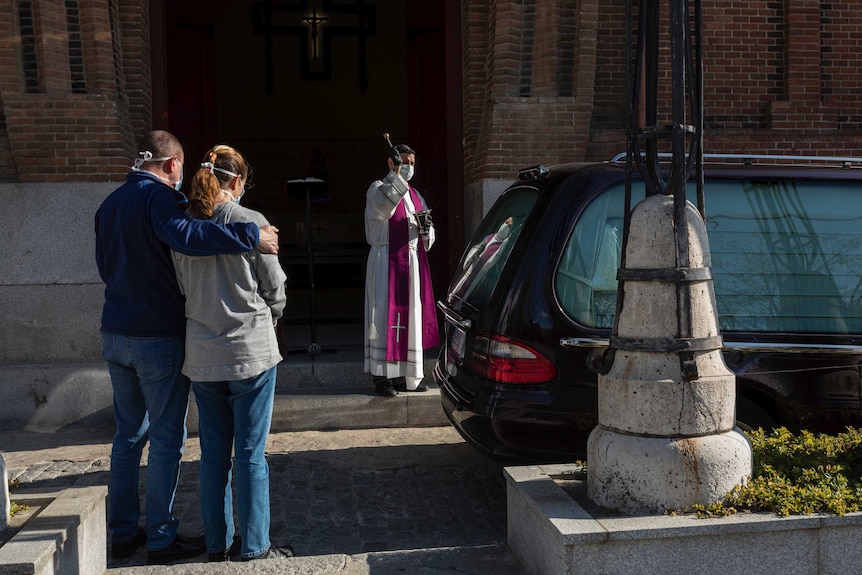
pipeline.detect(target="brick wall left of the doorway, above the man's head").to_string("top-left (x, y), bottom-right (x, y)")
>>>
top-left (0, 0), bottom-right (151, 182)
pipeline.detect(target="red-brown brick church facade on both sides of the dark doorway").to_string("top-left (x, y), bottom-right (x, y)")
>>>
top-left (0, 0), bottom-right (862, 184)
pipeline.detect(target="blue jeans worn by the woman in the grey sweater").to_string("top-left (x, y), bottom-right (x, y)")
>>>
top-left (192, 367), bottom-right (276, 558)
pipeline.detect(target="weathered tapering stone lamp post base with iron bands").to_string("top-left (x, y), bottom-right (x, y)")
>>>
top-left (587, 195), bottom-right (752, 514)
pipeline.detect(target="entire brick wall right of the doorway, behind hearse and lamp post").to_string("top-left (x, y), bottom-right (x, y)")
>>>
top-left (470, 0), bottom-right (862, 183)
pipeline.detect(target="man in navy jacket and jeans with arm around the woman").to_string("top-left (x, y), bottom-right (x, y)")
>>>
top-left (95, 130), bottom-right (278, 564)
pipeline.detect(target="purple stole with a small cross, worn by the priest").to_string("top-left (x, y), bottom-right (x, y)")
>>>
top-left (386, 188), bottom-right (439, 361)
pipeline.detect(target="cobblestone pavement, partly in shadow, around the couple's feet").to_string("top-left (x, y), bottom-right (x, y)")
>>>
top-left (0, 427), bottom-right (506, 568)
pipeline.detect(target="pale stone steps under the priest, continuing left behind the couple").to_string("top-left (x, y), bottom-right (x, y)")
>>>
top-left (0, 344), bottom-right (448, 432)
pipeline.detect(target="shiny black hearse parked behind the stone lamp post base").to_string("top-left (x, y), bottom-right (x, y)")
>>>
top-left (434, 155), bottom-right (862, 461)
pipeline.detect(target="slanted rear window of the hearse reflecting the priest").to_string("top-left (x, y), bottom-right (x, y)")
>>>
top-left (448, 188), bottom-right (539, 308)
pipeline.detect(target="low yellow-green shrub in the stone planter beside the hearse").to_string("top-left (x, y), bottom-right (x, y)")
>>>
top-left (694, 427), bottom-right (862, 517)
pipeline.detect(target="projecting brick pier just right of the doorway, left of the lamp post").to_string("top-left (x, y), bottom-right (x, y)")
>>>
top-left (462, 0), bottom-right (599, 184)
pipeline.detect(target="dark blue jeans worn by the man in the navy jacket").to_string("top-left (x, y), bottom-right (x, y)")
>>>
top-left (102, 333), bottom-right (189, 550)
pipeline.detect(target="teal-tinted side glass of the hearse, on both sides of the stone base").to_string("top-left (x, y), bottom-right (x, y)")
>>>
top-left (554, 179), bottom-right (862, 333)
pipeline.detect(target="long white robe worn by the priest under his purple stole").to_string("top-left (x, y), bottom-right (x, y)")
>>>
top-left (365, 171), bottom-right (435, 389)
